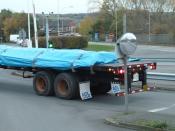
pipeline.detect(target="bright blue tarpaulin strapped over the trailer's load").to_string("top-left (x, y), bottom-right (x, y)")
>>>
top-left (0, 45), bottom-right (137, 70)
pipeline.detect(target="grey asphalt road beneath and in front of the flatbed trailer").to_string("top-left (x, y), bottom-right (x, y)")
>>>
top-left (0, 70), bottom-right (175, 131)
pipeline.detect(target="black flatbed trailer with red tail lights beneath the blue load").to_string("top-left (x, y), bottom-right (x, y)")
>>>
top-left (0, 57), bottom-right (156, 99)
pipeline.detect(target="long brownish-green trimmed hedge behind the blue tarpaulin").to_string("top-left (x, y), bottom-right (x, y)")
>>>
top-left (32, 36), bottom-right (88, 49)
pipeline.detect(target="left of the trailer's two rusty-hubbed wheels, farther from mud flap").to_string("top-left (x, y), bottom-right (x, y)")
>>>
top-left (33, 71), bottom-right (55, 96)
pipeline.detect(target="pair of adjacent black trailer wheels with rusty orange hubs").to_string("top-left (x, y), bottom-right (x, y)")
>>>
top-left (33, 71), bottom-right (79, 99)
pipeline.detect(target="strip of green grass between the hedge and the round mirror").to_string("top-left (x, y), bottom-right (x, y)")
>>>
top-left (85, 44), bottom-right (115, 51)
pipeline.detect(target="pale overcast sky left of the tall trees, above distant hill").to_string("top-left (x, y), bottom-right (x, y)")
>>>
top-left (0, 0), bottom-right (95, 14)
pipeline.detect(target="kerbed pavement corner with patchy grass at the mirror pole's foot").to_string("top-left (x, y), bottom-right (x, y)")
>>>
top-left (105, 112), bottom-right (175, 131)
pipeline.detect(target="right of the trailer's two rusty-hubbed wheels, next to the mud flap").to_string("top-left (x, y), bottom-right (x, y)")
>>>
top-left (54, 73), bottom-right (79, 100)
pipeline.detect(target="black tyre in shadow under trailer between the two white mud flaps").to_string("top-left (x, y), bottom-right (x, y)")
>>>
top-left (91, 83), bottom-right (111, 95)
